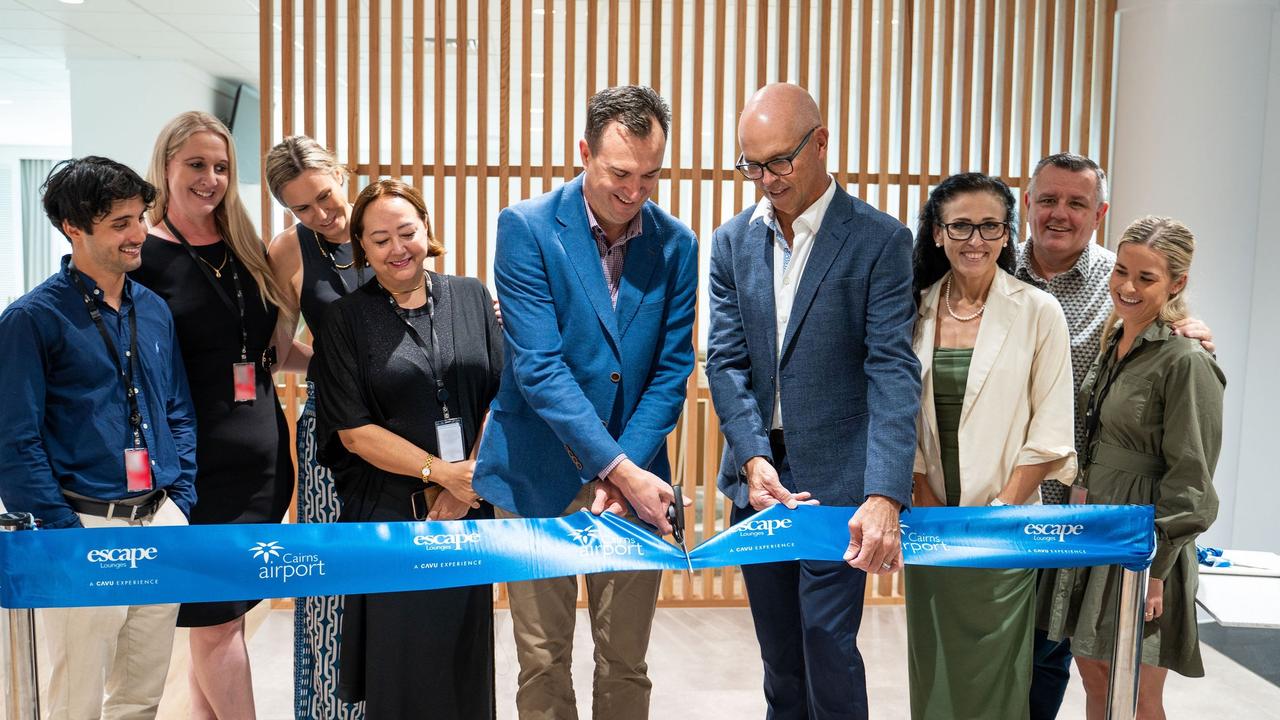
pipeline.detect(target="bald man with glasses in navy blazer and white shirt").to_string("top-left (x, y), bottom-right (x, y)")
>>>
top-left (707, 85), bottom-right (920, 720)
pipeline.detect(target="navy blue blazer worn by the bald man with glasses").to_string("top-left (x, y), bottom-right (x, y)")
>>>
top-left (707, 188), bottom-right (920, 507)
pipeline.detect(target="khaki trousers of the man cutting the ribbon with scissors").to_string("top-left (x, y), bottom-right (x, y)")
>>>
top-left (495, 483), bottom-right (662, 720)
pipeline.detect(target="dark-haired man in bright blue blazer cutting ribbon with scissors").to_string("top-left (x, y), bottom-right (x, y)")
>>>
top-left (472, 86), bottom-right (698, 720)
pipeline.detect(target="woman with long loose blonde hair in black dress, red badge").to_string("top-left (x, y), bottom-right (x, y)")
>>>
top-left (132, 111), bottom-right (308, 717)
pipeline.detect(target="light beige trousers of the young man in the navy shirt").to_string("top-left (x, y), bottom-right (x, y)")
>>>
top-left (38, 500), bottom-right (187, 720)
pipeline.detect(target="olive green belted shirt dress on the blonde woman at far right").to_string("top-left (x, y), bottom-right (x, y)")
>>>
top-left (1038, 322), bottom-right (1226, 678)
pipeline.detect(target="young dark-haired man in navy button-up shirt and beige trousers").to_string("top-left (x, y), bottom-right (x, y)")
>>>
top-left (0, 158), bottom-right (196, 719)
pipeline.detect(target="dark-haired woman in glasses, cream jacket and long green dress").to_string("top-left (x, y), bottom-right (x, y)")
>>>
top-left (906, 173), bottom-right (1075, 720)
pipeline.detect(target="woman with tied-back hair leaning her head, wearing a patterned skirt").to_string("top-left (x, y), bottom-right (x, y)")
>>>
top-left (266, 136), bottom-right (365, 720)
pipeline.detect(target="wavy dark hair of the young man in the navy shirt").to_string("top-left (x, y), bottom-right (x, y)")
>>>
top-left (40, 155), bottom-right (156, 240)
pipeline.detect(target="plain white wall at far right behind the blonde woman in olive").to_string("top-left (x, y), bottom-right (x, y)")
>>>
top-left (1108, 0), bottom-right (1280, 550)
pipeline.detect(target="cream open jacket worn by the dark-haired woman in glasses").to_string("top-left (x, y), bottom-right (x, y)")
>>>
top-left (911, 270), bottom-right (1076, 505)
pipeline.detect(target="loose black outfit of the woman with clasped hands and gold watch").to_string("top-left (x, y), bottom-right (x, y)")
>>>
top-left (312, 273), bottom-right (502, 720)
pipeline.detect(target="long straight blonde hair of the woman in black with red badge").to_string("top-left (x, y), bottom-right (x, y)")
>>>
top-left (147, 110), bottom-right (291, 318)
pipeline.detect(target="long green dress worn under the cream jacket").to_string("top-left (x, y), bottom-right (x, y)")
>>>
top-left (906, 347), bottom-right (1036, 720)
